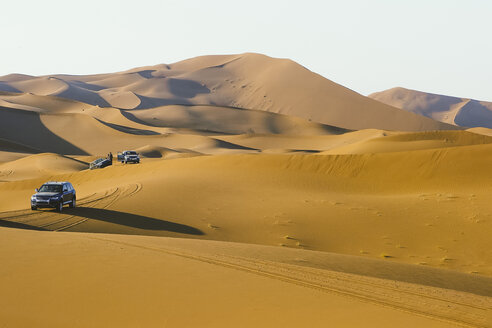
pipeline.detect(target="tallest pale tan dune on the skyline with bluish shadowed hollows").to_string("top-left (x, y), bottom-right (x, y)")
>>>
top-left (0, 53), bottom-right (453, 131)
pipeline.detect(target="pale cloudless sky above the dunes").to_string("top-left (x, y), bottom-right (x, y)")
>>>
top-left (0, 0), bottom-right (492, 101)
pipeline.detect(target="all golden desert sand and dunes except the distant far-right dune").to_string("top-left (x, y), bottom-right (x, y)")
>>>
top-left (0, 54), bottom-right (492, 327)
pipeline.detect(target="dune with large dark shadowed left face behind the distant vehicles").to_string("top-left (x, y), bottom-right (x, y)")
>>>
top-left (0, 104), bottom-right (266, 155)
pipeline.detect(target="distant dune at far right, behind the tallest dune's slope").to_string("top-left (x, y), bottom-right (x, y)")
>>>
top-left (369, 88), bottom-right (492, 128)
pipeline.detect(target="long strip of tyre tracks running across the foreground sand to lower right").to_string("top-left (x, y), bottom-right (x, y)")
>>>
top-left (90, 237), bottom-right (492, 328)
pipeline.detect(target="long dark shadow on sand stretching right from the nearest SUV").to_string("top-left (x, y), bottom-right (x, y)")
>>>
top-left (64, 207), bottom-right (204, 236)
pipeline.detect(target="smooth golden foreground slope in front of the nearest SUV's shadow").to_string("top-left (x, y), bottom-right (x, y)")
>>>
top-left (0, 228), bottom-right (490, 327)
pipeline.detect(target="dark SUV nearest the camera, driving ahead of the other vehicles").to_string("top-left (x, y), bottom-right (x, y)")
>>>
top-left (31, 182), bottom-right (76, 212)
